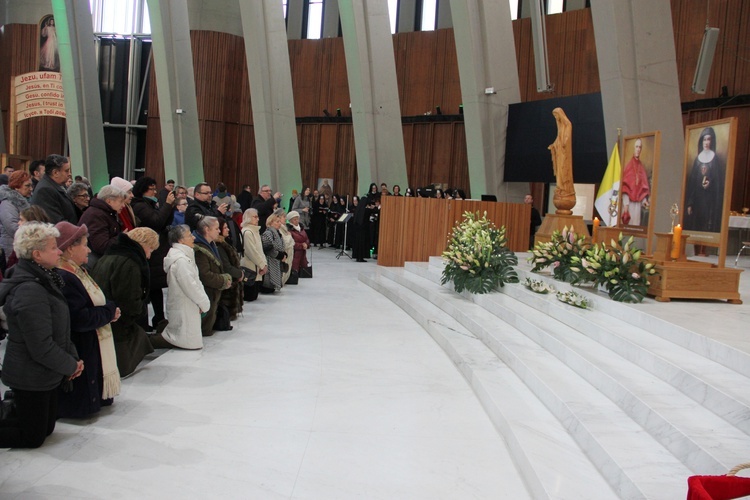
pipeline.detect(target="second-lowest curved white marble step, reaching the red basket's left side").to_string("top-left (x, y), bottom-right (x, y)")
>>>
top-left (364, 269), bottom-right (690, 498)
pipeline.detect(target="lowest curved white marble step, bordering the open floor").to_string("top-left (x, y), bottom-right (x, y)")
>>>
top-left (360, 271), bottom-right (617, 499)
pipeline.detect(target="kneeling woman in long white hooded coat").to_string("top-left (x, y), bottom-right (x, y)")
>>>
top-left (151, 224), bottom-right (211, 349)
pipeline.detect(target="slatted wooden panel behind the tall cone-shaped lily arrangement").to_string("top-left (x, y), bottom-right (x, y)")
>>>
top-left (378, 196), bottom-right (531, 267)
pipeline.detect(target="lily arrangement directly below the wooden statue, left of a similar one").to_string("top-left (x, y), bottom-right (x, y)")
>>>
top-left (528, 226), bottom-right (593, 283)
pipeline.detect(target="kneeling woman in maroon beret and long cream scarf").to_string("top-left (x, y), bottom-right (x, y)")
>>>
top-left (55, 221), bottom-right (120, 418)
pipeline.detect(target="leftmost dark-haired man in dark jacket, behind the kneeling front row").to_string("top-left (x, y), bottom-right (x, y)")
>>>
top-left (31, 155), bottom-right (78, 224)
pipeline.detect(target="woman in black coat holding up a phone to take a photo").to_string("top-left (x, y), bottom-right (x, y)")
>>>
top-left (130, 177), bottom-right (175, 329)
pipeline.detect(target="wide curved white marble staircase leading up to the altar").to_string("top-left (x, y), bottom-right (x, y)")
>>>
top-left (360, 258), bottom-right (750, 499)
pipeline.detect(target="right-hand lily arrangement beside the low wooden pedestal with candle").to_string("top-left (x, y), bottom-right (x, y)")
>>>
top-left (581, 233), bottom-right (656, 302)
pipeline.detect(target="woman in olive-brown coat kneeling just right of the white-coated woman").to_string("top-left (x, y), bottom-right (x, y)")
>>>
top-left (193, 216), bottom-right (232, 337)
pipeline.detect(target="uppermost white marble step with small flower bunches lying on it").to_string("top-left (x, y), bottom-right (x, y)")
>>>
top-left (414, 261), bottom-right (750, 436)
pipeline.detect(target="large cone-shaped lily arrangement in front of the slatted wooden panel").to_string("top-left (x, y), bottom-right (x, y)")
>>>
top-left (441, 212), bottom-right (518, 293)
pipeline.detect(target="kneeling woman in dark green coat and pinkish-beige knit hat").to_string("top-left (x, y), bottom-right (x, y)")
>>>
top-left (92, 229), bottom-right (159, 377)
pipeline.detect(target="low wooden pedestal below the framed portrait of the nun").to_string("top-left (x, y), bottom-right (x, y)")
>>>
top-left (647, 233), bottom-right (742, 304)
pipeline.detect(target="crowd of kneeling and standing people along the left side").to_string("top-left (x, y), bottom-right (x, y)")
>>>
top-left (0, 155), bottom-right (470, 448)
